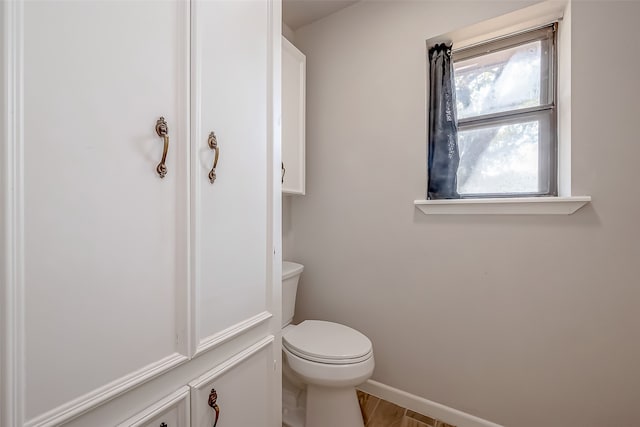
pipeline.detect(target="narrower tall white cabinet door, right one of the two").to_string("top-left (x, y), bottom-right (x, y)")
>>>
top-left (192, 0), bottom-right (272, 354)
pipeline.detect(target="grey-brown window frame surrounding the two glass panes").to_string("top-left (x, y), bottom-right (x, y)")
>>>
top-left (452, 21), bottom-right (559, 199)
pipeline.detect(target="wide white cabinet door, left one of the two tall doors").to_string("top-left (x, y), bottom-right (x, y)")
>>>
top-left (20, 1), bottom-right (189, 426)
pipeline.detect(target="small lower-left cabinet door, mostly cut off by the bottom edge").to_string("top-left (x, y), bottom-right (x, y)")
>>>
top-left (118, 386), bottom-right (190, 427)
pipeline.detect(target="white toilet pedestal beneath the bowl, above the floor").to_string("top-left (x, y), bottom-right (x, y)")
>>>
top-left (305, 384), bottom-right (364, 427)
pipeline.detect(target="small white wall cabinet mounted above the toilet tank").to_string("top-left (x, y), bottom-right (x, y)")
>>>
top-left (282, 37), bottom-right (307, 194)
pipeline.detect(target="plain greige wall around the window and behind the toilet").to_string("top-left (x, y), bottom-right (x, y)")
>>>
top-left (284, 0), bottom-right (640, 427)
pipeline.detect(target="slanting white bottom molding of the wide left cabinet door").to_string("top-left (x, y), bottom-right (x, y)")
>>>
top-left (25, 353), bottom-right (189, 427)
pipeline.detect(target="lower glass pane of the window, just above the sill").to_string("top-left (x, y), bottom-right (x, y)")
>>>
top-left (458, 120), bottom-right (540, 195)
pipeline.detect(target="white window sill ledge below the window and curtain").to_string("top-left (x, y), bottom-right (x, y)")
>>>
top-left (413, 196), bottom-right (591, 215)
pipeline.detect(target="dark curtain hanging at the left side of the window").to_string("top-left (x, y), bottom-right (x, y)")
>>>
top-left (427, 43), bottom-right (460, 199)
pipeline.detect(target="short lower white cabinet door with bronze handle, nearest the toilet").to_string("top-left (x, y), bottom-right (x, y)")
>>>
top-left (189, 336), bottom-right (272, 427)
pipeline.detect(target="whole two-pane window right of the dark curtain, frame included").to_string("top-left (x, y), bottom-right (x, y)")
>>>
top-left (453, 24), bottom-right (558, 198)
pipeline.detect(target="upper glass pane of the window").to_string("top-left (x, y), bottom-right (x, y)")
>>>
top-left (454, 40), bottom-right (548, 119)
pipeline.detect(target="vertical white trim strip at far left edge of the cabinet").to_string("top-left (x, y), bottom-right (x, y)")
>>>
top-left (0, 1), bottom-right (25, 426)
